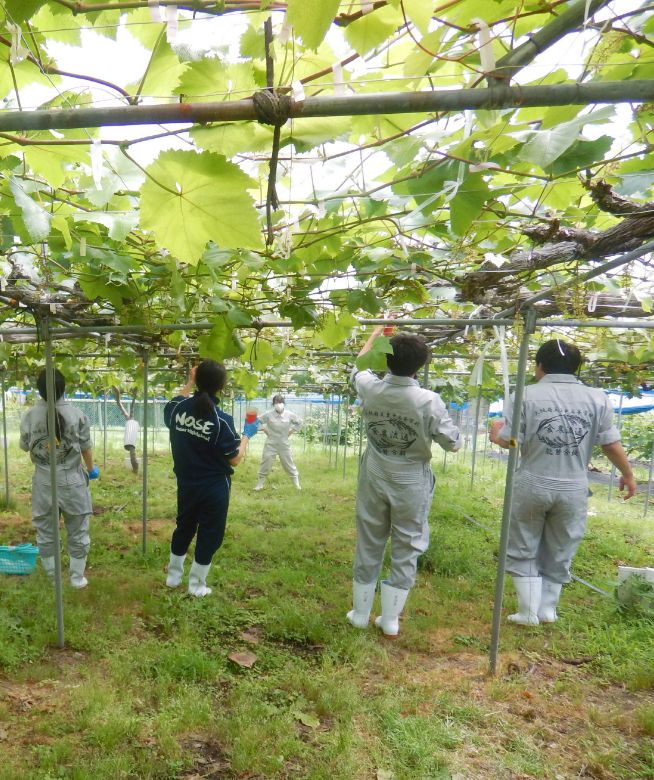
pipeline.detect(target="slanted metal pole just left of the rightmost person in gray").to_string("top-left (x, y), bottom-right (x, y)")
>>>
top-left (489, 309), bottom-right (536, 674)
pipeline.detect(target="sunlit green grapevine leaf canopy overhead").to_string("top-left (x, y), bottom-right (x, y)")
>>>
top-left (0, 0), bottom-right (654, 395)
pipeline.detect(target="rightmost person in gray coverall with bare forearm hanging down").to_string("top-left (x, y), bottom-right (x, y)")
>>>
top-left (490, 339), bottom-right (636, 625)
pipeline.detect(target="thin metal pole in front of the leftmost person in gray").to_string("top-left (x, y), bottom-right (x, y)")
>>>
top-left (41, 317), bottom-right (64, 647)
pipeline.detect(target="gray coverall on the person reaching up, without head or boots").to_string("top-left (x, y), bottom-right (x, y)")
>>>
top-left (352, 369), bottom-right (461, 590)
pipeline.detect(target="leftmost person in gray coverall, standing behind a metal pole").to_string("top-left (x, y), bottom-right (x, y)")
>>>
top-left (20, 370), bottom-right (100, 588)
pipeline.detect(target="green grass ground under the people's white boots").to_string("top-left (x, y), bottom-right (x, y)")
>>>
top-left (0, 440), bottom-right (654, 780)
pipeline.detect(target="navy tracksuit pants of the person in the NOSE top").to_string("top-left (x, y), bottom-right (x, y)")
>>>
top-left (170, 474), bottom-right (231, 566)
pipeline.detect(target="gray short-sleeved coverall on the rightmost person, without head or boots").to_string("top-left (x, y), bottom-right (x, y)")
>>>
top-left (499, 374), bottom-right (620, 583)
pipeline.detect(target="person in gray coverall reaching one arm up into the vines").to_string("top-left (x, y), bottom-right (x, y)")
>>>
top-left (347, 326), bottom-right (461, 637)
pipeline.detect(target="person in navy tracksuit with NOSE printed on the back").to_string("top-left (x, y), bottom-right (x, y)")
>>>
top-left (164, 360), bottom-right (258, 596)
